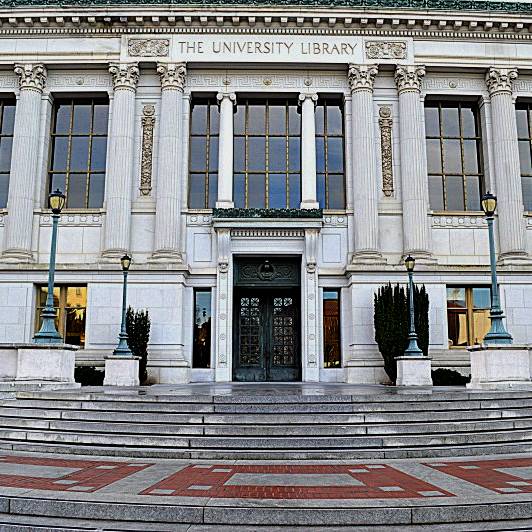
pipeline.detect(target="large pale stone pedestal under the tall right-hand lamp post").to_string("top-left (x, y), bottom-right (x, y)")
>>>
top-left (467, 344), bottom-right (532, 390)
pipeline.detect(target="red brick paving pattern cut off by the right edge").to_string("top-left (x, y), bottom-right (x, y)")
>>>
top-left (425, 458), bottom-right (532, 494)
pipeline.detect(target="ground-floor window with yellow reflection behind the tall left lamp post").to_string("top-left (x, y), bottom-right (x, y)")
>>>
top-left (35, 286), bottom-right (87, 347)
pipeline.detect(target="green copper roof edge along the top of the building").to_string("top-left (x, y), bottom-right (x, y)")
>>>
top-left (0, 0), bottom-right (532, 14)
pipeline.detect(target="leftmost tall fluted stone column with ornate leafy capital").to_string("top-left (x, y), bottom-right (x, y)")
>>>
top-left (2, 63), bottom-right (46, 261)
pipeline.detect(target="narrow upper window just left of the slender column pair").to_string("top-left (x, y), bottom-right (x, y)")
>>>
top-left (188, 98), bottom-right (220, 209)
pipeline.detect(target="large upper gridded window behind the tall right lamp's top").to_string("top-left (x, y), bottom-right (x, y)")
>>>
top-left (425, 102), bottom-right (483, 211)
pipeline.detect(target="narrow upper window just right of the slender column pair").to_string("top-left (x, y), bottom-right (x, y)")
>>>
top-left (315, 101), bottom-right (345, 209)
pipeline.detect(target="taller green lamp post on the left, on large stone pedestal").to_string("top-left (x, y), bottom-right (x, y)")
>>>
top-left (33, 189), bottom-right (66, 344)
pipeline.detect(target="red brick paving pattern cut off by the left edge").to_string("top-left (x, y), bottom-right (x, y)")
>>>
top-left (0, 456), bottom-right (151, 493)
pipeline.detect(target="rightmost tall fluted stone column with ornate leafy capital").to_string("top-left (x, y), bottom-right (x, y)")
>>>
top-left (486, 68), bottom-right (529, 264)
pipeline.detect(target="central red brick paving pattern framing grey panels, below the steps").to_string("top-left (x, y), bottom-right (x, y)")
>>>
top-left (141, 465), bottom-right (454, 499)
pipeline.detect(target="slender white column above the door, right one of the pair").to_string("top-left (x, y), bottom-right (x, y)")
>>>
top-left (299, 93), bottom-right (319, 209)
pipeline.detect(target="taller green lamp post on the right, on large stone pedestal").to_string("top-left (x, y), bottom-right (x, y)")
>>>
top-left (481, 192), bottom-right (513, 344)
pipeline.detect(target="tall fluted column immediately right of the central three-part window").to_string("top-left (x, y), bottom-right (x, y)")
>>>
top-left (348, 65), bottom-right (383, 263)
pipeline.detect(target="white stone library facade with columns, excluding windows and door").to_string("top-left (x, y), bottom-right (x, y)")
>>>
top-left (0, 6), bottom-right (532, 383)
